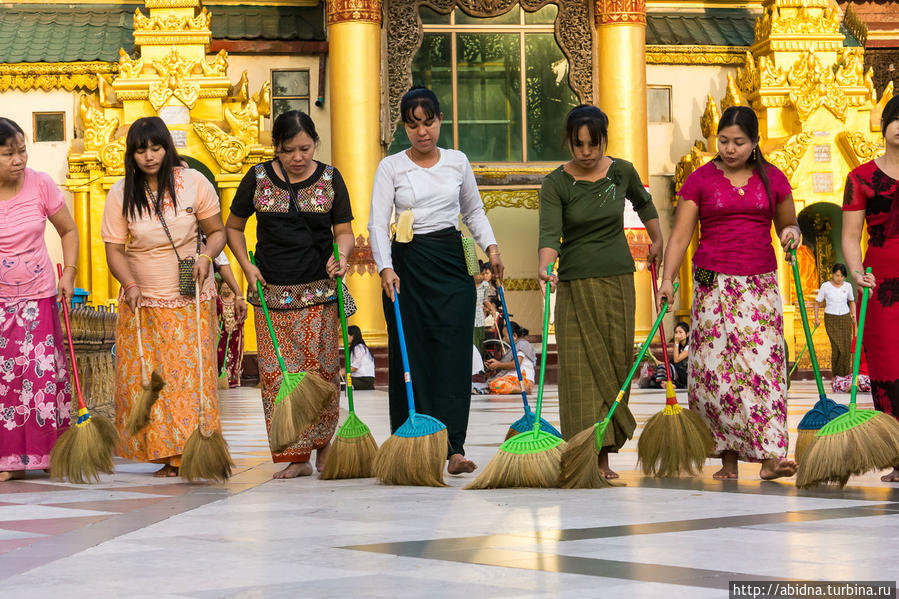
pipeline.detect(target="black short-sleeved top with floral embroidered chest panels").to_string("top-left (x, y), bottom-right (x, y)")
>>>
top-left (231, 161), bottom-right (353, 285)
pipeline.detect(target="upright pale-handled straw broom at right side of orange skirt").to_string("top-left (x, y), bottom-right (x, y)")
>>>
top-left (179, 281), bottom-right (234, 483)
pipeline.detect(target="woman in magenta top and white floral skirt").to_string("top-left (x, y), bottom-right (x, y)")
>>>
top-left (658, 106), bottom-right (801, 480)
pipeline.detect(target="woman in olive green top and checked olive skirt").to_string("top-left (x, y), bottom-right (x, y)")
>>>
top-left (539, 105), bottom-right (662, 478)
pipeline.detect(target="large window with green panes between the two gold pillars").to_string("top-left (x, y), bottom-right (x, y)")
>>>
top-left (390, 4), bottom-right (579, 162)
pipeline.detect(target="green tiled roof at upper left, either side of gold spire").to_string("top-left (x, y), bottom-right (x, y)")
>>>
top-left (0, 4), bottom-right (325, 63)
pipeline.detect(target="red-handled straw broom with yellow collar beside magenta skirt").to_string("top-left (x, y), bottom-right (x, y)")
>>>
top-left (50, 264), bottom-right (119, 484)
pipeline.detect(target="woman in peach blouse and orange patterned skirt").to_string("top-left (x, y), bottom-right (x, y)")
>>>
top-left (101, 117), bottom-right (225, 476)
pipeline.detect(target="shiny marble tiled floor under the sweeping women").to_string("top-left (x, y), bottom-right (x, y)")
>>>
top-left (0, 382), bottom-right (899, 599)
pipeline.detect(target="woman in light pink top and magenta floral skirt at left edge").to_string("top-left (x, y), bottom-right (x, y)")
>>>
top-left (0, 118), bottom-right (78, 481)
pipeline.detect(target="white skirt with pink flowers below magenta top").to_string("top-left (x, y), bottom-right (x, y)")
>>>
top-left (687, 272), bottom-right (789, 462)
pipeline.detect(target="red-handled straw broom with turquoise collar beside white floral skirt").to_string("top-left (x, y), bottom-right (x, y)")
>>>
top-left (637, 263), bottom-right (715, 478)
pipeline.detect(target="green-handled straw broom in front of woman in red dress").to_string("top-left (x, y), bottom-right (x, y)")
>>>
top-left (796, 267), bottom-right (899, 489)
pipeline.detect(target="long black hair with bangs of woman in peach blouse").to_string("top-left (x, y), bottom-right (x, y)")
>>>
top-left (122, 116), bottom-right (181, 220)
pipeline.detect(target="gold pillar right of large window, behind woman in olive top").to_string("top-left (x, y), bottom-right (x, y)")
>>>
top-left (595, 0), bottom-right (655, 339)
